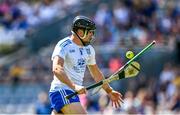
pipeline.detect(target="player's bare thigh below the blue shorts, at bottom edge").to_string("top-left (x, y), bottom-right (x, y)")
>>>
top-left (61, 102), bottom-right (87, 114)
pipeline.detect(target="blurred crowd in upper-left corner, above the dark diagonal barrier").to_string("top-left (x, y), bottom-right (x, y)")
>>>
top-left (0, 0), bottom-right (80, 44)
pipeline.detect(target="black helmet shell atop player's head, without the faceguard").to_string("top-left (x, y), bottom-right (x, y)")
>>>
top-left (72, 16), bottom-right (96, 32)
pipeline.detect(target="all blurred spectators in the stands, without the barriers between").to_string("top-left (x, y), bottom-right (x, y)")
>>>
top-left (0, 0), bottom-right (180, 114)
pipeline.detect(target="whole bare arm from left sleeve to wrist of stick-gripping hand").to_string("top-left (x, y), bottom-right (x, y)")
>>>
top-left (52, 56), bottom-right (75, 89)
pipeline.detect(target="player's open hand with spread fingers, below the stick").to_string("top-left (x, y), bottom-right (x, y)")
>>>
top-left (108, 90), bottom-right (123, 108)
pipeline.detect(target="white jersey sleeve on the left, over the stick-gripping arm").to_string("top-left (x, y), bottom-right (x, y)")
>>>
top-left (51, 43), bottom-right (66, 60)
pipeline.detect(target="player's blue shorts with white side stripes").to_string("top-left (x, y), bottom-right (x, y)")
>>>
top-left (49, 89), bottom-right (80, 112)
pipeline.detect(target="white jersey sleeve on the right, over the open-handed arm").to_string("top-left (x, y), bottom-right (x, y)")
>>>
top-left (87, 46), bottom-right (96, 65)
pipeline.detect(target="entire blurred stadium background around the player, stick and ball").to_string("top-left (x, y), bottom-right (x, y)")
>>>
top-left (0, 0), bottom-right (180, 114)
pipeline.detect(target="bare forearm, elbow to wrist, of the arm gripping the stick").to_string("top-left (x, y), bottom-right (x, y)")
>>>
top-left (53, 70), bottom-right (75, 89)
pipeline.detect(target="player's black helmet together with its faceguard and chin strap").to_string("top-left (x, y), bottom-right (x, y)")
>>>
top-left (72, 16), bottom-right (96, 46)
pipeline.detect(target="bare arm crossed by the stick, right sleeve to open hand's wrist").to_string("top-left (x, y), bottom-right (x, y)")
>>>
top-left (88, 64), bottom-right (112, 93)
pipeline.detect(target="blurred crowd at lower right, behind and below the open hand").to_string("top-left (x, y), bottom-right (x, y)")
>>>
top-left (82, 62), bottom-right (180, 114)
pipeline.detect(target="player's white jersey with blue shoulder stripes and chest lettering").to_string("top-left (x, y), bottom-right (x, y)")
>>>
top-left (50, 37), bottom-right (96, 92)
